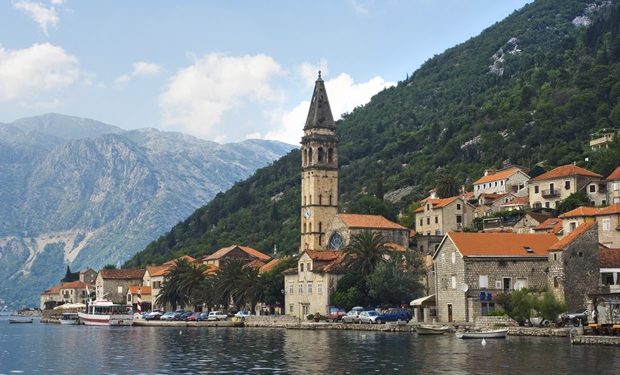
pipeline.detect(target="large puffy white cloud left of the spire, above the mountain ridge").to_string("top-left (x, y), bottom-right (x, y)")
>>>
top-left (158, 53), bottom-right (284, 140)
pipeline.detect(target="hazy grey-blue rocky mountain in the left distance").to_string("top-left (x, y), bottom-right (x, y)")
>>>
top-left (0, 114), bottom-right (293, 305)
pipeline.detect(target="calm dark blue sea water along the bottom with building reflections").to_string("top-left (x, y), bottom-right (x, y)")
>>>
top-left (0, 320), bottom-right (620, 375)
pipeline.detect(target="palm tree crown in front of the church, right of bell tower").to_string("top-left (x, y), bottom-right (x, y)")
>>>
top-left (344, 230), bottom-right (388, 277)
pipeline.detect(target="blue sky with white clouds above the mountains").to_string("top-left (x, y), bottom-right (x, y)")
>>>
top-left (0, 0), bottom-right (531, 144)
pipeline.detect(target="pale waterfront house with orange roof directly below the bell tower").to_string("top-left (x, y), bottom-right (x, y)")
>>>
top-left (284, 250), bottom-right (344, 319)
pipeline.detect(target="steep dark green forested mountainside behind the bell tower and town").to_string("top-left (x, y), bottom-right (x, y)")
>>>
top-left (126, 0), bottom-right (620, 266)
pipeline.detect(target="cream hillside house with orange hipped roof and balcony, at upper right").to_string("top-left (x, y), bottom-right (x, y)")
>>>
top-left (528, 164), bottom-right (607, 209)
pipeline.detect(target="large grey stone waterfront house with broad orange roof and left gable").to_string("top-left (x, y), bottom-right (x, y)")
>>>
top-left (433, 232), bottom-right (557, 322)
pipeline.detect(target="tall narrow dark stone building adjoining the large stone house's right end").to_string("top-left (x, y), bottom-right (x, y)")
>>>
top-left (547, 222), bottom-right (600, 311)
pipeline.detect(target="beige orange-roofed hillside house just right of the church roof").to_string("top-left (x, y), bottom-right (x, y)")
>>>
top-left (415, 196), bottom-right (475, 236)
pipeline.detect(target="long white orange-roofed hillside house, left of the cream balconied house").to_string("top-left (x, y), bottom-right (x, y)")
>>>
top-left (474, 167), bottom-right (530, 197)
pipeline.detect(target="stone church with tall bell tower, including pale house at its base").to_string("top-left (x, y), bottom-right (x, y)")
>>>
top-left (284, 72), bottom-right (409, 319)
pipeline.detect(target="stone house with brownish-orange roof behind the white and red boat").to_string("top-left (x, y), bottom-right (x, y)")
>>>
top-left (95, 269), bottom-right (145, 304)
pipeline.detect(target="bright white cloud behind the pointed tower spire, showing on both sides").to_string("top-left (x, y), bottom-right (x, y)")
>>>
top-left (264, 70), bottom-right (396, 144)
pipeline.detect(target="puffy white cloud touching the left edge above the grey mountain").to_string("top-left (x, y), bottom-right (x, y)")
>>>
top-left (0, 43), bottom-right (80, 100)
